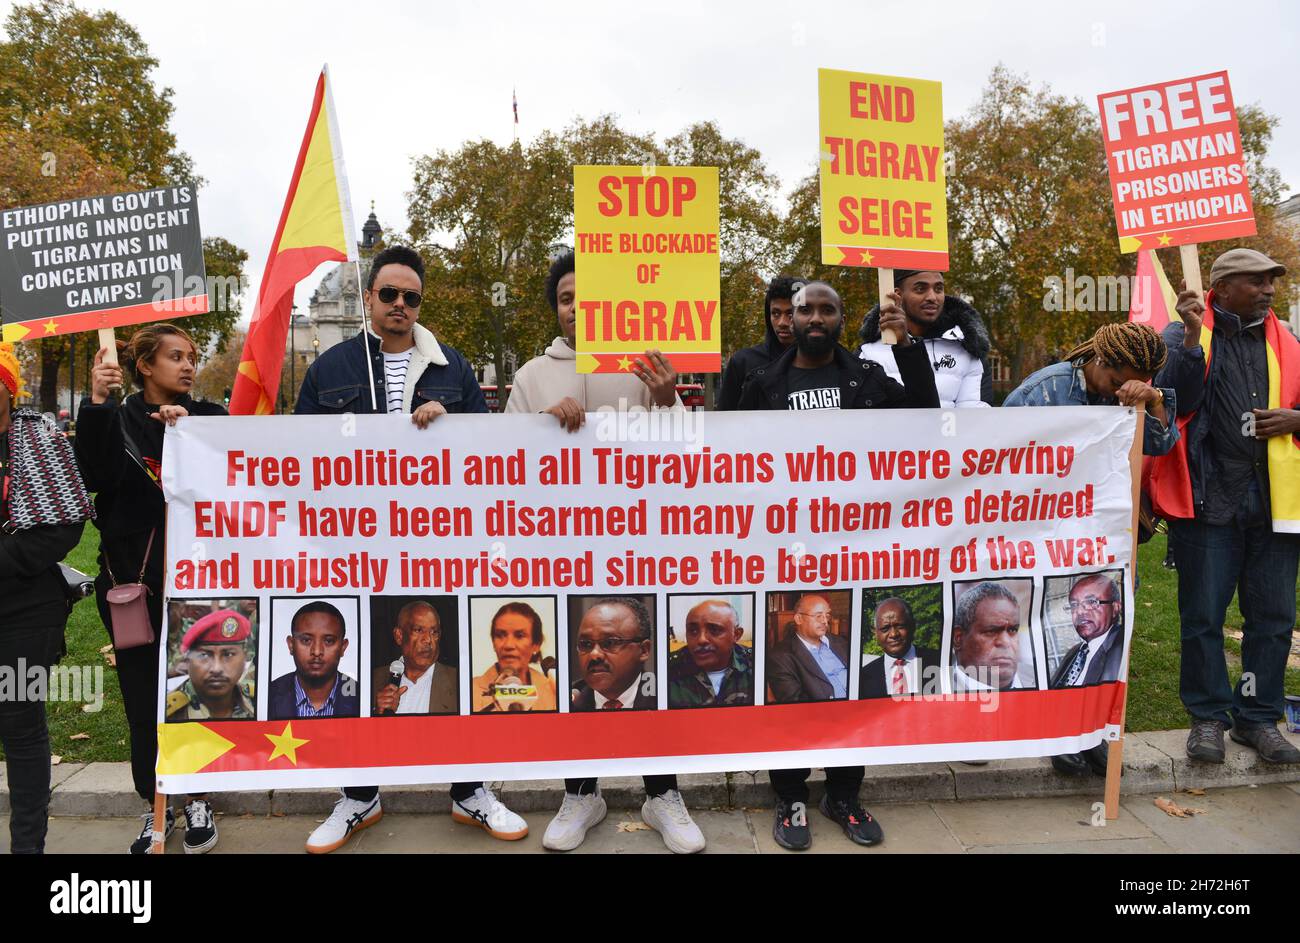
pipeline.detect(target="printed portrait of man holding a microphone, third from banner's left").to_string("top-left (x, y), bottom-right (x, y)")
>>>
top-left (372, 600), bottom-right (460, 715)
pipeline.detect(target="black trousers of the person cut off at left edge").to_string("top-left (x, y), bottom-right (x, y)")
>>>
top-left (0, 626), bottom-right (59, 855)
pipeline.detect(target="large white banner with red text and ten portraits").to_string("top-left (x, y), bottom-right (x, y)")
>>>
top-left (157, 407), bottom-right (1136, 793)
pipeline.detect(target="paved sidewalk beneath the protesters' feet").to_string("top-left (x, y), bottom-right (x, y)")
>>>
top-left (0, 783), bottom-right (1300, 855)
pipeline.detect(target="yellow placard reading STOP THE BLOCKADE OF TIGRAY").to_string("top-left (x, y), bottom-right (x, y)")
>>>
top-left (573, 165), bottom-right (722, 373)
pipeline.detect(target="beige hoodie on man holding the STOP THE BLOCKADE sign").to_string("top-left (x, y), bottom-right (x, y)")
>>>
top-left (506, 337), bottom-right (686, 412)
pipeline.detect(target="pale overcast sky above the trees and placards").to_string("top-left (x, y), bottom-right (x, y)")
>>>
top-left (0, 0), bottom-right (1300, 316)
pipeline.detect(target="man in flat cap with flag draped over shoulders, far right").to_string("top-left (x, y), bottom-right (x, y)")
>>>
top-left (1148, 248), bottom-right (1300, 764)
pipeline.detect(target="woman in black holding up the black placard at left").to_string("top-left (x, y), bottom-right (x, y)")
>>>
top-left (77, 324), bottom-right (226, 855)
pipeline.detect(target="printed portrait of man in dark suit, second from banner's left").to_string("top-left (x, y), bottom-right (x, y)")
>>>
top-left (268, 600), bottom-right (361, 721)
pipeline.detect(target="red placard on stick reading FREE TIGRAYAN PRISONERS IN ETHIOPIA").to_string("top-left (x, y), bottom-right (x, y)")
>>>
top-left (1097, 72), bottom-right (1255, 293)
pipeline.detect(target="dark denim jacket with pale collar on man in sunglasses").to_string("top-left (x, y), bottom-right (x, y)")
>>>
top-left (294, 324), bottom-right (488, 416)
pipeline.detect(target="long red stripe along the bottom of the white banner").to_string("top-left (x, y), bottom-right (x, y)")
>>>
top-left (189, 682), bottom-right (1125, 773)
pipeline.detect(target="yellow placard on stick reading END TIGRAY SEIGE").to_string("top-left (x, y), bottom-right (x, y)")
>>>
top-left (818, 69), bottom-right (948, 343)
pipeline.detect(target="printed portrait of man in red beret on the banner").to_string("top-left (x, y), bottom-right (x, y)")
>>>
top-left (166, 609), bottom-right (257, 723)
